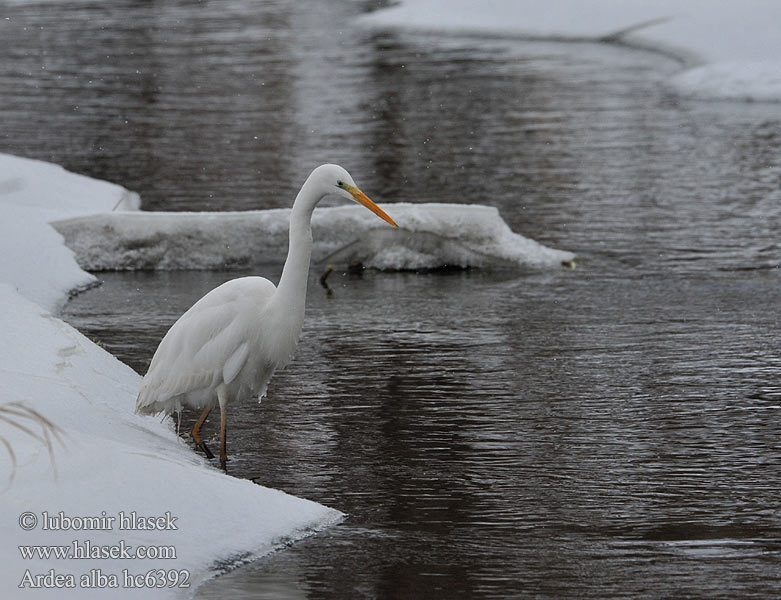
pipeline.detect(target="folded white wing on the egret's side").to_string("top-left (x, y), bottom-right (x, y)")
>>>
top-left (136, 277), bottom-right (276, 413)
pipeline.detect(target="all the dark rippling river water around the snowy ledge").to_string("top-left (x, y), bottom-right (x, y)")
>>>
top-left (6, 0), bottom-right (781, 599)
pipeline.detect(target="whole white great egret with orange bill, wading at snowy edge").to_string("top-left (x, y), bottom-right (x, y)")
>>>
top-left (136, 165), bottom-right (397, 469)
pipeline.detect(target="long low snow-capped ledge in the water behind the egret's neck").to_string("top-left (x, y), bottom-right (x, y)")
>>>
top-left (53, 204), bottom-right (574, 271)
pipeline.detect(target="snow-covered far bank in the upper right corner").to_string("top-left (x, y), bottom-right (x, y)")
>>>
top-left (360, 0), bottom-right (781, 102)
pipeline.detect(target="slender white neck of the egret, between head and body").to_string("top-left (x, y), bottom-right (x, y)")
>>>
top-left (276, 181), bottom-right (320, 318)
